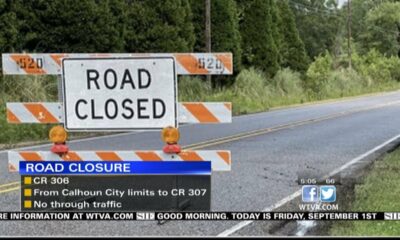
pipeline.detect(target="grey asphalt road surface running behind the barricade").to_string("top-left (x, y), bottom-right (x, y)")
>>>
top-left (0, 92), bottom-right (400, 236)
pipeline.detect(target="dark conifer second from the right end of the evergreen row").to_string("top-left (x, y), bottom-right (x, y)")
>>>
top-left (240, 0), bottom-right (279, 76)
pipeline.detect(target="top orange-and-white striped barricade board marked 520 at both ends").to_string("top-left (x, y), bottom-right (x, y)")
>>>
top-left (2, 53), bottom-right (233, 75)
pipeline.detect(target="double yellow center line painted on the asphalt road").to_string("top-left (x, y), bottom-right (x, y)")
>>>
top-left (0, 101), bottom-right (400, 194)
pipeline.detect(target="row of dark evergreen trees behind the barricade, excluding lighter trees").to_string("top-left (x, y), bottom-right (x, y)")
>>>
top-left (0, 0), bottom-right (308, 75)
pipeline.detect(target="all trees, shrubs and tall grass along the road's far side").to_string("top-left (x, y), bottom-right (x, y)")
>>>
top-left (0, 0), bottom-right (400, 144)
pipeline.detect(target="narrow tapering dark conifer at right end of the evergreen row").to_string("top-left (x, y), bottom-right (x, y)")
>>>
top-left (277, 0), bottom-right (309, 72)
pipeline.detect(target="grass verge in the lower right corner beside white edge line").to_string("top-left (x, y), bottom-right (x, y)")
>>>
top-left (330, 149), bottom-right (400, 236)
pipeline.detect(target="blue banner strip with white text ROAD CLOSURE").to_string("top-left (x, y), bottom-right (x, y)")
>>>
top-left (19, 161), bottom-right (211, 175)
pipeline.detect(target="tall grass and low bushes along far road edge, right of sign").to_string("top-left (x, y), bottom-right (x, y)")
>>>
top-left (178, 50), bottom-right (400, 115)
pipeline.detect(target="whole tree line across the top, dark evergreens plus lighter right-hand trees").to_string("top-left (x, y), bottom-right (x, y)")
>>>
top-left (0, 0), bottom-right (400, 80)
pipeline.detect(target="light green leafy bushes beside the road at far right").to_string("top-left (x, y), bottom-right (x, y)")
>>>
top-left (305, 50), bottom-right (400, 99)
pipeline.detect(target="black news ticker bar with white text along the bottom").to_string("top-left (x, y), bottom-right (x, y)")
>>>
top-left (0, 212), bottom-right (400, 221)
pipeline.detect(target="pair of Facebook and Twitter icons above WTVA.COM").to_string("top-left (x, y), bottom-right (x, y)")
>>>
top-left (302, 185), bottom-right (336, 202)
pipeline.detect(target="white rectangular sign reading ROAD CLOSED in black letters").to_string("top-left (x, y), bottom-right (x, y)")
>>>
top-left (63, 57), bottom-right (177, 131)
